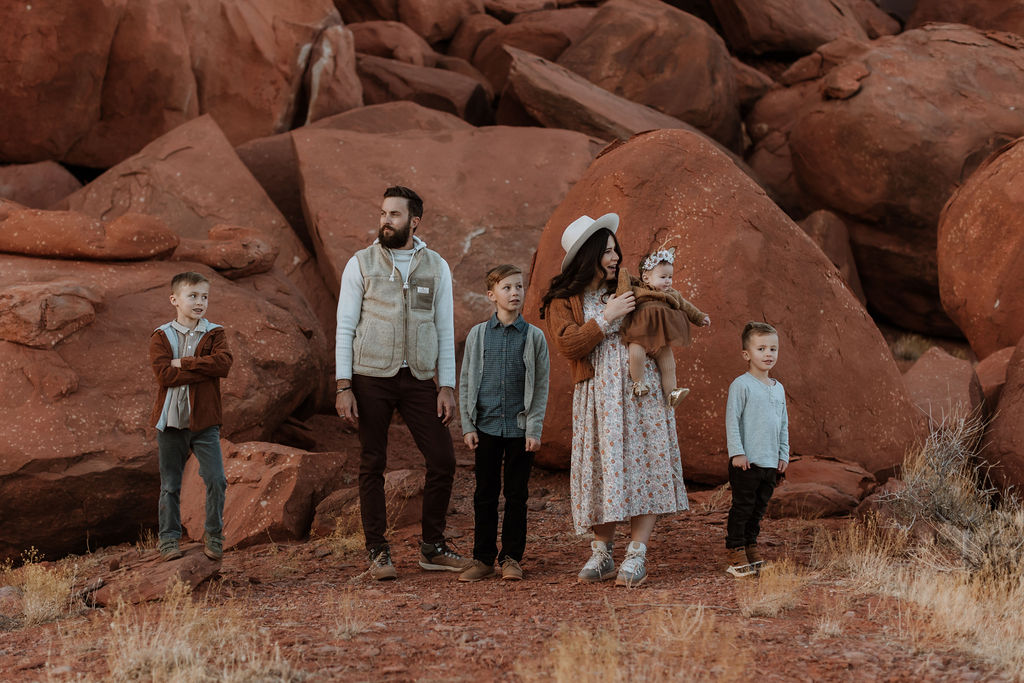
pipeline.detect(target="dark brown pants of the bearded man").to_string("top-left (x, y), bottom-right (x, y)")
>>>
top-left (352, 368), bottom-right (455, 550)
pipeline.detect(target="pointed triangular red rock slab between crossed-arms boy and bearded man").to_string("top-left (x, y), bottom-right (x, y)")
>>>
top-left (61, 117), bottom-right (336, 348)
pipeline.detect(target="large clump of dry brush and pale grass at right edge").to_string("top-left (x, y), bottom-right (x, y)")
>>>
top-left (815, 415), bottom-right (1024, 676)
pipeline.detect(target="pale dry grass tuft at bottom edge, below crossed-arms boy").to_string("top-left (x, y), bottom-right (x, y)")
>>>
top-left (105, 583), bottom-right (305, 683)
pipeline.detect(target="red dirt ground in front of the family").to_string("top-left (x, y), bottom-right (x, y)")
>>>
top-left (0, 417), bottom-right (1000, 681)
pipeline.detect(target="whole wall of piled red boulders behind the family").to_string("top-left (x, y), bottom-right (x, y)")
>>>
top-left (0, 0), bottom-right (1024, 558)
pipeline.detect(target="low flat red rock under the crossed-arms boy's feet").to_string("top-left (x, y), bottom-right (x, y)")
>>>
top-left (87, 544), bottom-right (220, 607)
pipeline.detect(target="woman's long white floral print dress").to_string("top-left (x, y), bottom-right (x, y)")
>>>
top-left (569, 291), bottom-right (689, 535)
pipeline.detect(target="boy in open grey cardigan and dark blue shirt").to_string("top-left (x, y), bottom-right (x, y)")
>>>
top-left (459, 264), bottom-right (549, 582)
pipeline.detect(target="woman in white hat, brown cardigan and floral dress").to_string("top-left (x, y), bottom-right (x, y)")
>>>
top-left (541, 213), bottom-right (689, 586)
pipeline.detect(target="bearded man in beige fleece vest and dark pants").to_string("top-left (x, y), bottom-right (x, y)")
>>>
top-left (335, 186), bottom-right (472, 581)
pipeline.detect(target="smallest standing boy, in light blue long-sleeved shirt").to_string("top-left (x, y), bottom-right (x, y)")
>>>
top-left (725, 322), bottom-right (790, 577)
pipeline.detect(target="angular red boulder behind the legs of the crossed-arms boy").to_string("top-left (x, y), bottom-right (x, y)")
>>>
top-left (181, 441), bottom-right (356, 548)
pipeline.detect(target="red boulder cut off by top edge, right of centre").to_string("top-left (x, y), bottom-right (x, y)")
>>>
top-left (711, 0), bottom-right (867, 54)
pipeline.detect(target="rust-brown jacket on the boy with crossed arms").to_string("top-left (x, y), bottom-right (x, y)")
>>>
top-left (150, 327), bottom-right (232, 432)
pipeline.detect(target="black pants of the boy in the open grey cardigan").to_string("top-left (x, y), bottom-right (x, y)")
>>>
top-left (473, 432), bottom-right (534, 564)
